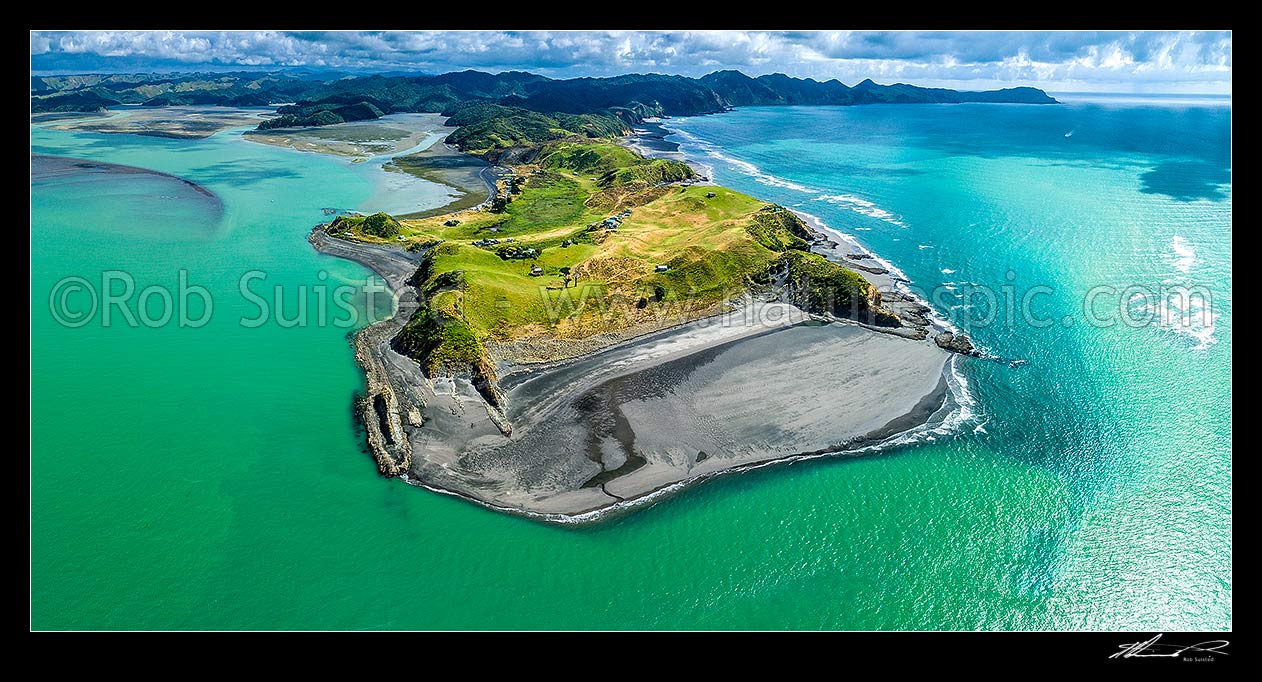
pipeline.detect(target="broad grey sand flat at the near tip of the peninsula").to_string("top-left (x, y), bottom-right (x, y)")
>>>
top-left (477, 314), bottom-right (948, 515)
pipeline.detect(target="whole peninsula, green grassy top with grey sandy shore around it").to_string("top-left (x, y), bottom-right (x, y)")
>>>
top-left (292, 98), bottom-right (970, 522)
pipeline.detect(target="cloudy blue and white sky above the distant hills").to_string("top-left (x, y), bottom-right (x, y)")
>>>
top-left (30, 30), bottom-right (1232, 95)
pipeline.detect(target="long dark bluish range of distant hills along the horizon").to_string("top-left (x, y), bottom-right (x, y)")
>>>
top-left (30, 71), bottom-right (1056, 117)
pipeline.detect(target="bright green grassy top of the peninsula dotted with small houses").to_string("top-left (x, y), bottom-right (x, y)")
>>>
top-left (333, 141), bottom-right (868, 371)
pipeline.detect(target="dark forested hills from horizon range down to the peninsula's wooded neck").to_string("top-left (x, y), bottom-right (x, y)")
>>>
top-left (30, 71), bottom-right (1056, 153)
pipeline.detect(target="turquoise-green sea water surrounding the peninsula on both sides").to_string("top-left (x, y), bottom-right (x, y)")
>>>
top-left (32, 101), bottom-right (1232, 629)
